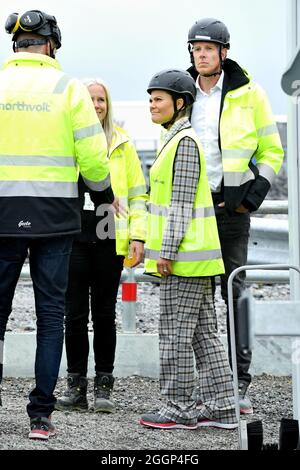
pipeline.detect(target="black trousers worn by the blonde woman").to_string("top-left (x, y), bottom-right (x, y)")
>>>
top-left (65, 240), bottom-right (124, 376)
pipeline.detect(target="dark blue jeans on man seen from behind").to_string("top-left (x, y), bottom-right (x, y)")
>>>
top-left (0, 236), bottom-right (73, 418)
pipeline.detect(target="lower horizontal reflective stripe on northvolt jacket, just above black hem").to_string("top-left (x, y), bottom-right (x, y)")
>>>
top-left (0, 181), bottom-right (78, 198)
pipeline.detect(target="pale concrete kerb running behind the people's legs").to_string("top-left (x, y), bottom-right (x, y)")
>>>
top-left (4, 333), bottom-right (292, 378)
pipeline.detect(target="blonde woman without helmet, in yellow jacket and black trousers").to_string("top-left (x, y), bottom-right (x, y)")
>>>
top-left (56, 79), bottom-right (147, 412)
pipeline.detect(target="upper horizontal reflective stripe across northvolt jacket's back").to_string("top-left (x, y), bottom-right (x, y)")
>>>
top-left (0, 155), bottom-right (76, 167)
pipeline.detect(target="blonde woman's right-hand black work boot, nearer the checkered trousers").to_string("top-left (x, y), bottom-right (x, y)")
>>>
top-left (94, 372), bottom-right (115, 413)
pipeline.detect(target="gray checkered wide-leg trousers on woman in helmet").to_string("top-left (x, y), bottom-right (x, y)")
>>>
top-left (159, 276), bottom-right (236, 424)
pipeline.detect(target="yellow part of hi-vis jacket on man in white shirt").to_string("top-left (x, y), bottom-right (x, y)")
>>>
top-left (220, 81), bottom-right (284, 189)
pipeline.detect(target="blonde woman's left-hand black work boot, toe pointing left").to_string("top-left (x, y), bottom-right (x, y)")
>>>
top-left (55, 374), bottom-right (88, 411)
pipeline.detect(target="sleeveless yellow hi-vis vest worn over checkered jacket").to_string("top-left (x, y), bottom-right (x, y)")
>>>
top-left (145, 128), bottom-right (224, 277)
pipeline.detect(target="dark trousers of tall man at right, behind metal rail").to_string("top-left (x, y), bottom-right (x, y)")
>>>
top-left (215, 205), bottom-right (251, 385)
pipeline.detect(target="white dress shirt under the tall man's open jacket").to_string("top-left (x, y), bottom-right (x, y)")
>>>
top-left (191, 71), bottom-right (224, 192)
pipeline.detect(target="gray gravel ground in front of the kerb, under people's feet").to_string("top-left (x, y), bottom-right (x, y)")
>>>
top-left (0, 375), bottom-right (292, 451)
